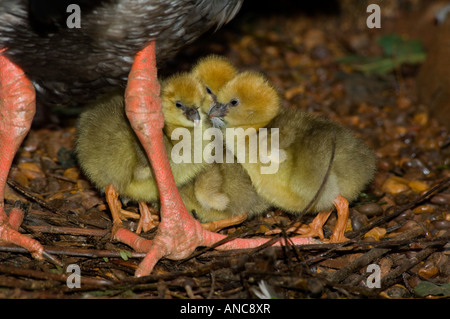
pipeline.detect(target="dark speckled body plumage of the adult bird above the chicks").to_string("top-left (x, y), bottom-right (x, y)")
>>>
top-left (0, 0), bottom-right (243, 105)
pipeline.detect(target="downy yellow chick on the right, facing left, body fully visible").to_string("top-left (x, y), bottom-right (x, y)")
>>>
top-left (209, 72), bottom-right (376, 242)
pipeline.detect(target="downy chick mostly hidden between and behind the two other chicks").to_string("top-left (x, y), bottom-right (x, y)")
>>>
top-left (180, 55), bottom-right (270, 228)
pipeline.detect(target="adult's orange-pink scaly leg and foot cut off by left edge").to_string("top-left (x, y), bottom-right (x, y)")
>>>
top-left (0, 50), bottom-right (44, 259)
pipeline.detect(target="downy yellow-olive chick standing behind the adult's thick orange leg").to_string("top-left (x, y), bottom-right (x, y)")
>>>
top-left (76, 73), bottom-right (212, 232)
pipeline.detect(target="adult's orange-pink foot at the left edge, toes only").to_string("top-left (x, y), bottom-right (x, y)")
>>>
top-left (0, 208), bottom-right (44, 260)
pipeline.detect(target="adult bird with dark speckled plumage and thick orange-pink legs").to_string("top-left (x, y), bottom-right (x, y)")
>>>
top-left (0, 0), bottom-right (243, 272)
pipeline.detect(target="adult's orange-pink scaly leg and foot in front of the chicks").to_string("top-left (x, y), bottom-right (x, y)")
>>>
top-left (115, 42), bottom-right (315, 277)
